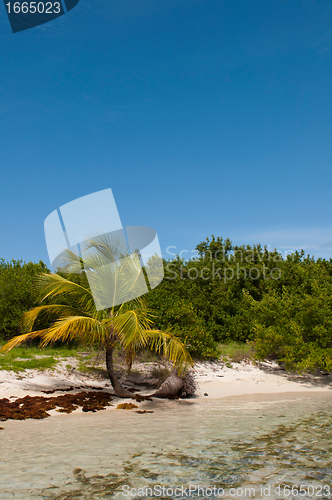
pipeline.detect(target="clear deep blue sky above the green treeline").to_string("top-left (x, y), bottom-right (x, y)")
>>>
top-left (0, 0), bottom-right (332, 264)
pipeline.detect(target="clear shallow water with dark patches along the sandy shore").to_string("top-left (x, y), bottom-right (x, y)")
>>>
top-left (0, 393), bottom-right (332, 500)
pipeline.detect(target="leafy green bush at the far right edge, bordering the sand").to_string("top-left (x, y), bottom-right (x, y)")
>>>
top-left (246, 262), bottom-right (332, 371)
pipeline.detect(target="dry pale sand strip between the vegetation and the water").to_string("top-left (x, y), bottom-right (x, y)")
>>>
top-left (0, 362), bottom-right (332, 399)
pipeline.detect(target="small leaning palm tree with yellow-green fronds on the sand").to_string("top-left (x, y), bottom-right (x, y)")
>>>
top-left (1, 235), bottom-right (193, 398)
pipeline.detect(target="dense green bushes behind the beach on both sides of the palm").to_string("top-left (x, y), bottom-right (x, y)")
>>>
top-left (0, 236), bottom-right (332, 371)
